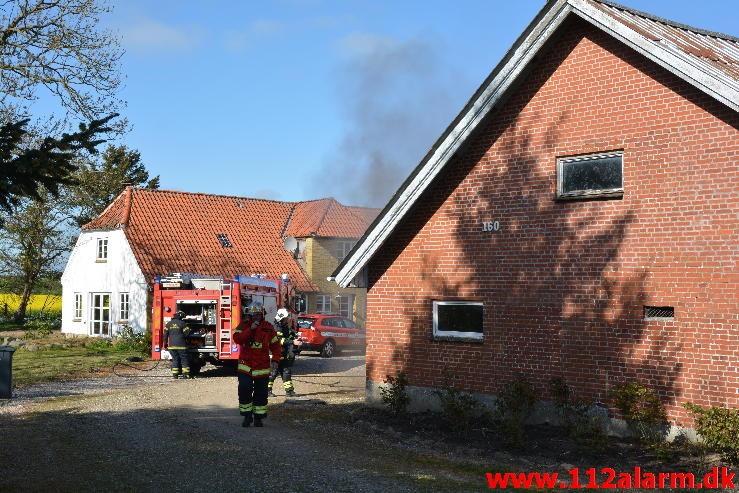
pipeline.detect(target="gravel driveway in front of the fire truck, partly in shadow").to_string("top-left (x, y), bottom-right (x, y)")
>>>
top-left (0, 355), bottom-right (485, 493)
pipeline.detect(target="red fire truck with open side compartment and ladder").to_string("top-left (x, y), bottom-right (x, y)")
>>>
top-left (151, 273), bottom-right (293, 373)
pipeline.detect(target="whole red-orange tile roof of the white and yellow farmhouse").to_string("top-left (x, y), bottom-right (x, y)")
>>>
top-left (82, 188), bottom-right (379, 291)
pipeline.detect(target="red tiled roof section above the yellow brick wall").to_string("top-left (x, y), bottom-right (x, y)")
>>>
top-left (285, 198), bottom-right (380, 238)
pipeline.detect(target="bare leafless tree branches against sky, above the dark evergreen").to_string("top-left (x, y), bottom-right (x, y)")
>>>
top-left (0, 0), bottom-right (123, 121)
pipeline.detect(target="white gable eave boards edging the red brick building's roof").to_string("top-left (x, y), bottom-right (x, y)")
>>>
top-left (333, 0), bottom-right (739, 287)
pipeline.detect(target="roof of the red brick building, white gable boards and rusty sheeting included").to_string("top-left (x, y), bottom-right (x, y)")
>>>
top-left (333, 0), bottom-right (739, 287)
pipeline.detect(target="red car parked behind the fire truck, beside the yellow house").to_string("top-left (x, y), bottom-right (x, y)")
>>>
top-left (295, 313), bottom-right (365, 358)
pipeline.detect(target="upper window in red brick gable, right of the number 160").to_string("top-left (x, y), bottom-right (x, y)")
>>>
top-left (557, 151), bottom-right (624, 198)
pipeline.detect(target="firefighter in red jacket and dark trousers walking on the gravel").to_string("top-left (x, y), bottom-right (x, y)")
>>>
top-left (233, 301), bottom-right (282, 427)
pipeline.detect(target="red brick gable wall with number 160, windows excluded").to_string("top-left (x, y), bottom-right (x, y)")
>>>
top-left (367, 16), bottom-right (739, 424)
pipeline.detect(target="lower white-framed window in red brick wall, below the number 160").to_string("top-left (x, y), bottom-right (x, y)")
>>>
top-left (433, 301), bottom-right (483, 340)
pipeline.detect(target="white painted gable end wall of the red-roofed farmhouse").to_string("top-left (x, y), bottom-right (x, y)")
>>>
top-left (62, 229), bottom-right (147, 335)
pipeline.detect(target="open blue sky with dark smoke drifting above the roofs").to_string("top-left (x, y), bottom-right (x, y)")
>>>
top-left (76, 0), bottom-right (739, 206)
